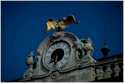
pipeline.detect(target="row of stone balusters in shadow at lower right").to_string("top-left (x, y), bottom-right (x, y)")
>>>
top-left (94, 60), bottom-right (123, 80)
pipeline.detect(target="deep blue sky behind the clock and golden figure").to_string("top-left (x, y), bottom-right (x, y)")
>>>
top-left (1, 1), bottom-right (123, 81)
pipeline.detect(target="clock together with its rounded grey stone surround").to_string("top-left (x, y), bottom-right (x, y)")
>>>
top-left (38, 32), bottom-right (79, 72)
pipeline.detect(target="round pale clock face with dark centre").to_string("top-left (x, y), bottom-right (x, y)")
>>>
top-left (43, 42), bottom-right (70, 70)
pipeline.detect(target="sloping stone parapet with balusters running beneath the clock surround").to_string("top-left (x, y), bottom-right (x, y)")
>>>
top-left (22, 54), bottom-right (123, 82)
